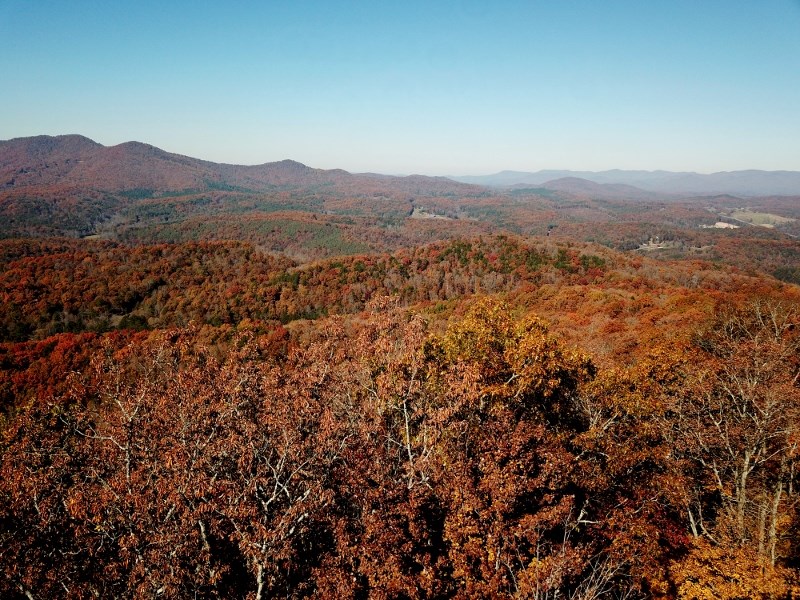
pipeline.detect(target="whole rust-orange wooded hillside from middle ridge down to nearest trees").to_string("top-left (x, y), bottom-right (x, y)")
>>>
top-left (0, 235), bottom-right (800, 599)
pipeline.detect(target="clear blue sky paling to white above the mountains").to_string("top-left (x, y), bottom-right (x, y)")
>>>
top-left (0, 0), bottom-right (800, 174)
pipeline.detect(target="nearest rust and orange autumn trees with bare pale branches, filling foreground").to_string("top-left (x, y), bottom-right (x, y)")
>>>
top-left (0, 298), bottom-right (800, 599)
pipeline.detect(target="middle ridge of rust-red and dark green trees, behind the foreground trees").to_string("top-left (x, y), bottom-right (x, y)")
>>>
top-left (0, 236), bottom-right (765, 341)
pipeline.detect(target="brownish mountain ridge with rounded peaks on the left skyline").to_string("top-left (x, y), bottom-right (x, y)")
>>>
top-left (0, 135), bottom-right (482, 195)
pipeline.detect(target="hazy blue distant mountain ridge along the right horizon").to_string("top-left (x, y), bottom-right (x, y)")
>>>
top-left (451, 169), bottom-right (800, 196)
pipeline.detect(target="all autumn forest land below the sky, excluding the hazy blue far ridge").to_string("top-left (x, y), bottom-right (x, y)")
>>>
top-left (0, 138), bottom-right (800, 600)
